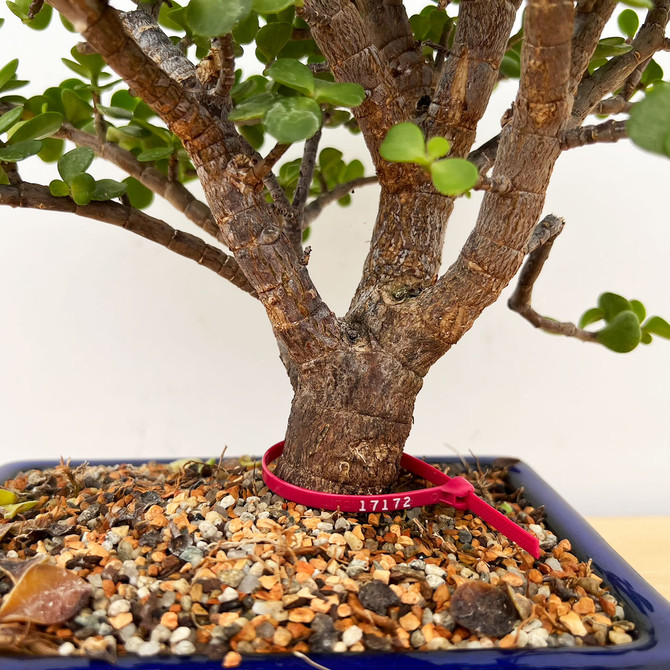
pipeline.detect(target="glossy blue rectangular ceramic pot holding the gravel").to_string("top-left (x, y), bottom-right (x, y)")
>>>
top-left (0, 457), bottom-right (670, 670)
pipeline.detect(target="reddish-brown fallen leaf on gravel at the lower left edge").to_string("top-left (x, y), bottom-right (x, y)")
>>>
top-left (0, 562), bottom-right (91, 625)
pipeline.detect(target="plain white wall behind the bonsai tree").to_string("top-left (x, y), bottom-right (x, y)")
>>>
top-left (0, 3), bottom-right (670, 515)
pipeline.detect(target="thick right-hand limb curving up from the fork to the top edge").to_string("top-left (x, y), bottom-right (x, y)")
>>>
top-left (394, 0), bottom-right (574, 372)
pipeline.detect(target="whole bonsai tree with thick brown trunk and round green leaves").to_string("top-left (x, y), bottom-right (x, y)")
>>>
top-left (0, 0), bottom-right (670, 493)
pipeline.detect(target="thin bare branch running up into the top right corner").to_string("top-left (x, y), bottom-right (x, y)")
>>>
top-left (570, 0), bottom-right (670, 128)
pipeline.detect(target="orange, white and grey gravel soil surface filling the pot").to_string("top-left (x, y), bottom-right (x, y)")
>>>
top-left (0, 458), bottom-right (635, 667)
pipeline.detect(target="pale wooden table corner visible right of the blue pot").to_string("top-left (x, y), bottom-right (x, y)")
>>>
top-left (587, 516), bottom-right (670, 600)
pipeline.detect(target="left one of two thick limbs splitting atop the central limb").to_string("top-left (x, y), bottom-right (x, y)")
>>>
top-left (298, 0), bottom-right (404, 174)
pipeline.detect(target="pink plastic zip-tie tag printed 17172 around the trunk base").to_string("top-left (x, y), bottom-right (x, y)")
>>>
top-left (263, 442), bottom-right (540, 558)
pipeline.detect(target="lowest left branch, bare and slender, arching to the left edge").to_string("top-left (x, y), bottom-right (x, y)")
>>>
top-left (0, 182), bottom-right (257, 297)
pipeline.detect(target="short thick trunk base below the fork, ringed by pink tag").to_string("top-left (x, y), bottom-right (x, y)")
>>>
top-left (277, 346), bottom-right (423, 494)
